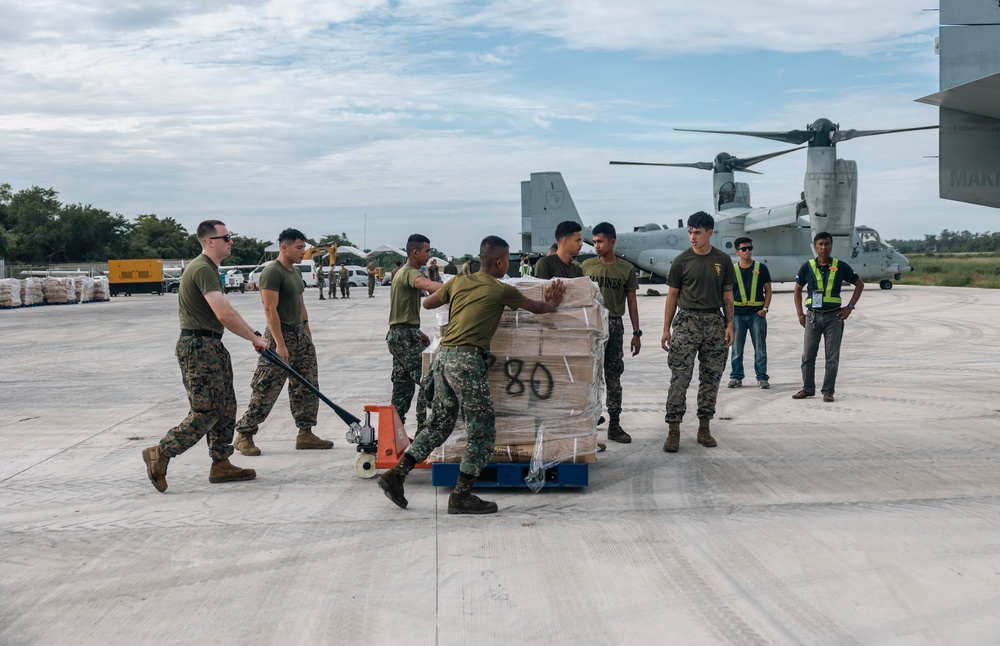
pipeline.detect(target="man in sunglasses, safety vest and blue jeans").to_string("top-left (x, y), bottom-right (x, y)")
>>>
top-left (729, 238), bottom-right (771, 390)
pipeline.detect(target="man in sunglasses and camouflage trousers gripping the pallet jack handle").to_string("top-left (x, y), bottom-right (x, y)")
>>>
top-left (142, 220), bottom-right (267, 493)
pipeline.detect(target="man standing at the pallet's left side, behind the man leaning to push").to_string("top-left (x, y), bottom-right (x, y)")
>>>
top-left (385, 233), bottom-right (441, 434)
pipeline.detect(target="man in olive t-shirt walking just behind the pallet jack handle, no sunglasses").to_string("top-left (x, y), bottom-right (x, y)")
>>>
top-left (235, 229), bottom-right (333, 456)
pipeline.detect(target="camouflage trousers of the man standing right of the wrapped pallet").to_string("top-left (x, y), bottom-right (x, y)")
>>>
top-left (665, 310), bottom-right (728, 423)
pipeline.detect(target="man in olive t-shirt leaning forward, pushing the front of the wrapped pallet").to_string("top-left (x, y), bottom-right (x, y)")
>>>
top-left (378, 236), bottom-right (563, 514)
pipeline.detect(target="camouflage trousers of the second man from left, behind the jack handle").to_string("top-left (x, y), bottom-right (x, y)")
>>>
top-left (236, 328), bottom-right (319, 435)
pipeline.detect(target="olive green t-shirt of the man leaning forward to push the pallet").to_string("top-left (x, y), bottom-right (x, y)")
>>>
top-left (436, 271), bottom-right (524, 350)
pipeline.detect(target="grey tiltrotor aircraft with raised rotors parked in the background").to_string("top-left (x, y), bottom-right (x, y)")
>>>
top-left (521, 119), bottom-right (937, 289)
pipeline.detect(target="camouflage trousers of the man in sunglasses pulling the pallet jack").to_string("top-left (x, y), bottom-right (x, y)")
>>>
top-left (160, 336), bottom-right (236, 462)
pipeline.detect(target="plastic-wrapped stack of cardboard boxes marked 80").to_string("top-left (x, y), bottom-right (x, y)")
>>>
top-left (423, 277), bottom-right (608, 491)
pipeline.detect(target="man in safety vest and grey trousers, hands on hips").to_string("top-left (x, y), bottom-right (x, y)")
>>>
top-left (792, 231), bottom-right (865, 402)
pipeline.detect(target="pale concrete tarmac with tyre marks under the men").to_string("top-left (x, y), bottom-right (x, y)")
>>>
top-left (0, 285), bottom-right (1000, 646)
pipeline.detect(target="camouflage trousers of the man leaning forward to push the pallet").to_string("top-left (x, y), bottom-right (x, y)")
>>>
top-left (406, 352), bottom-right (497, 477)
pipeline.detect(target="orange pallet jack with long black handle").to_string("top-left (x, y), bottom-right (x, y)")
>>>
top-left (260, 348), bottom-right (431, 478)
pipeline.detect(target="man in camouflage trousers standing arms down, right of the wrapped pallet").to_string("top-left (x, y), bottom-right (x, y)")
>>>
top-left (660, 211), bottom-right (736, 453)
